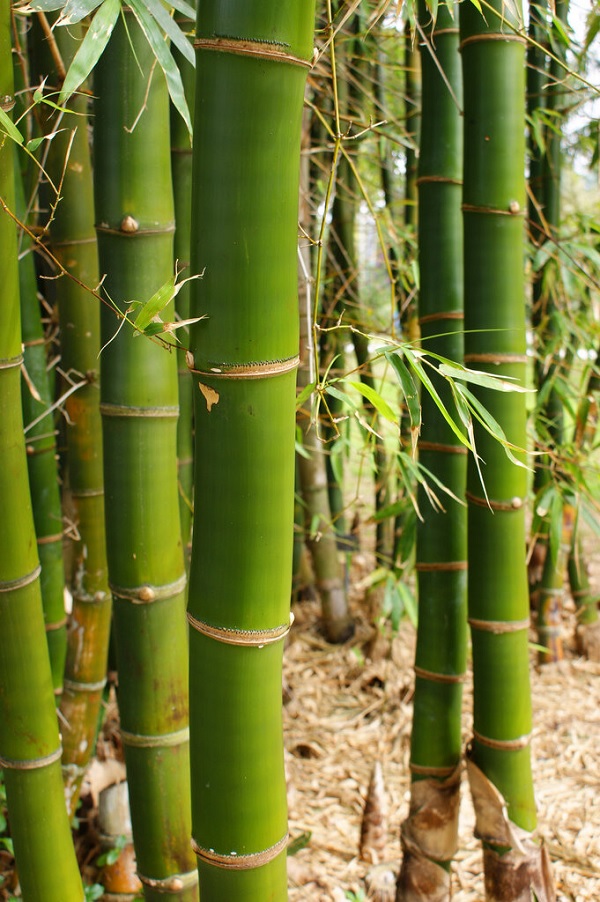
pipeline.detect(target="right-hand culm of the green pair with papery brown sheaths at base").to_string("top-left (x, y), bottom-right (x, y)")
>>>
top-left (460, 3), bottom-right (554, 902)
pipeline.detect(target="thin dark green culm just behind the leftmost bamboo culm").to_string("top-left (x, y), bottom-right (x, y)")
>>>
top-left (16, 161), bottom-right (67, 696)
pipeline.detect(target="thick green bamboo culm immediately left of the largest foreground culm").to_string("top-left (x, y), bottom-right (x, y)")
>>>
top-left (94, 9), bottom-right (198, 902)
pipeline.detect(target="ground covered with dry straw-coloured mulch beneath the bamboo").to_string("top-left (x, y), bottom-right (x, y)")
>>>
top-left (284, 556), bottom-right (600, 902)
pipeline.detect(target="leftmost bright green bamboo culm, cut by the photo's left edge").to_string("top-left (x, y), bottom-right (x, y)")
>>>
top-left (0, 0), bottom-right (83, 902)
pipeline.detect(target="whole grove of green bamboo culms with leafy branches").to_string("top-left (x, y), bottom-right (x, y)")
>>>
top-left (0, 0), bottom-right (600, 902)
